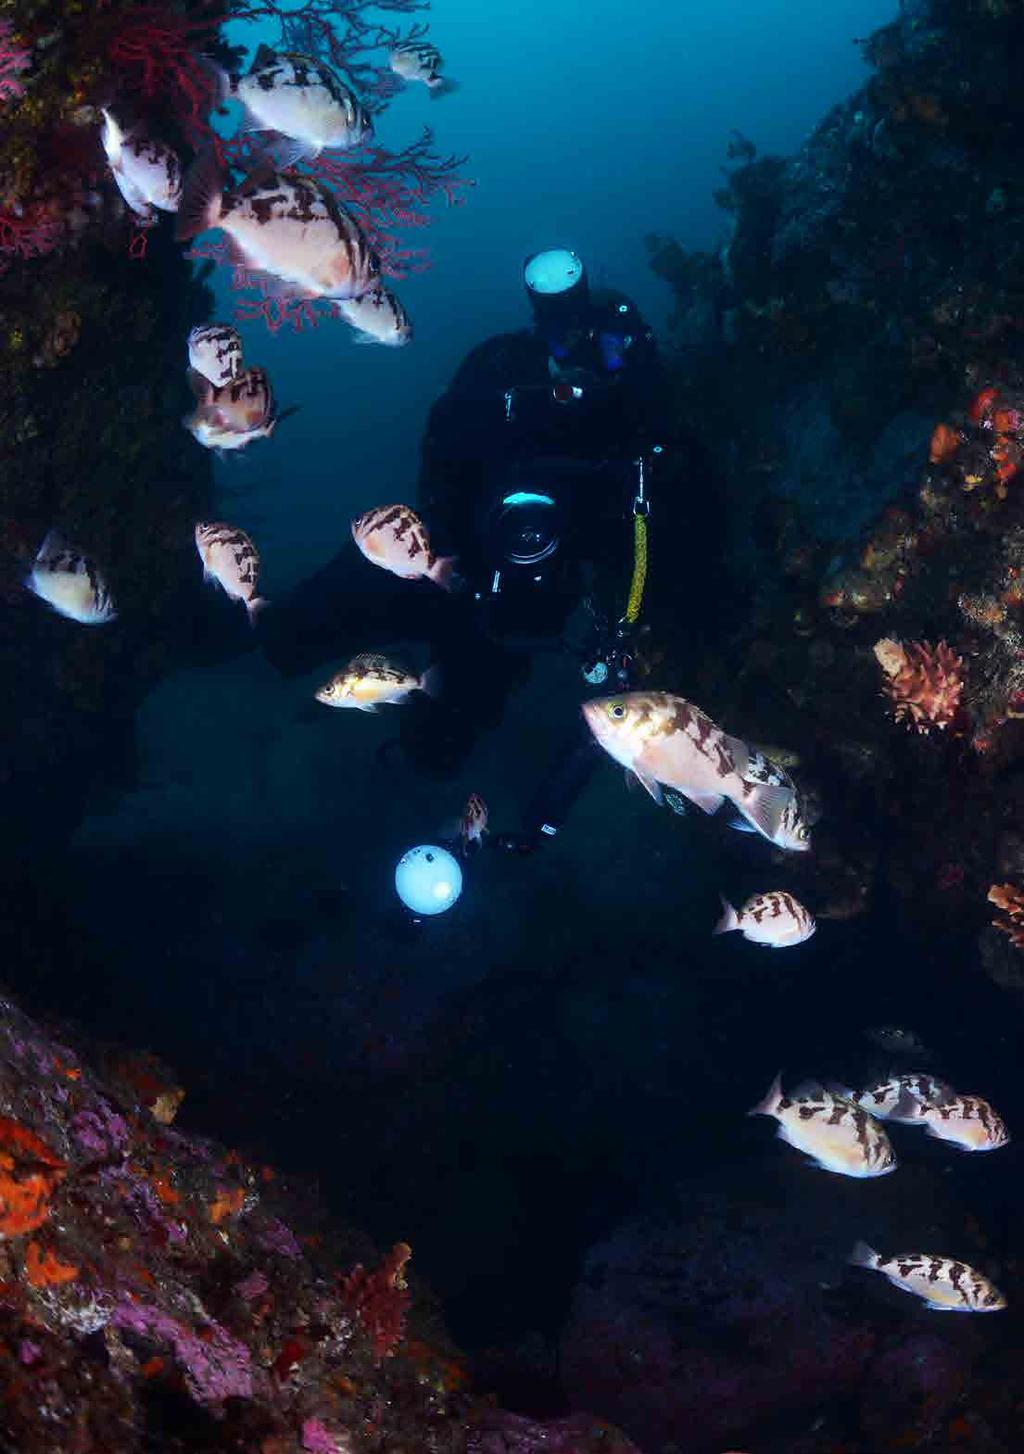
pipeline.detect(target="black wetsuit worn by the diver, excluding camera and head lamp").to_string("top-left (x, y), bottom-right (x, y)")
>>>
top-left (257, 283), bottom-right (680, 838)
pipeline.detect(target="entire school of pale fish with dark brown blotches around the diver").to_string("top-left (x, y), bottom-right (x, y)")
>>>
top-left (25, 19), bottom-right (1009, 1349)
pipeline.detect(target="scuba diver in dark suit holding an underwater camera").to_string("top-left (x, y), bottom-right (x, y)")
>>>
top-left (256, 249), bottom-right (712, 851)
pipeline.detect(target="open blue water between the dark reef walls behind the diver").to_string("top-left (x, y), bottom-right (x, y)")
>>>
top-left (221, 0), bottom-right (896, 593)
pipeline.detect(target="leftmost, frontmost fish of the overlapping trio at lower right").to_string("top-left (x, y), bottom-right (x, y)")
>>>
top-left (748, 1076), bottom-right (896, 1176)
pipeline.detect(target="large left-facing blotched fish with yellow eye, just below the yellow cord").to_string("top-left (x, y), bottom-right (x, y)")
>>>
top-left (583, 692), bottom-right (796, 842)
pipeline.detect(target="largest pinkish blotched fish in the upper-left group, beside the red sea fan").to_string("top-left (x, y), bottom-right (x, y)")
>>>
top-left (175, 150), bottom-right (381, 298)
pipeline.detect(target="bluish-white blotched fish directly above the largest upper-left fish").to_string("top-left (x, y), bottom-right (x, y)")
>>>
top-left (225, 45), bottom-right (374, 169)
